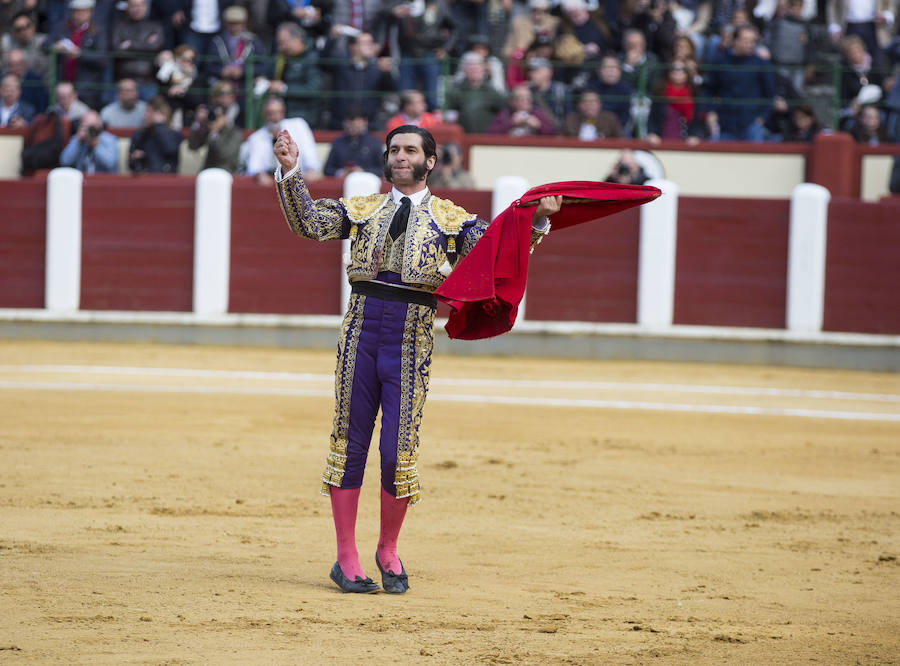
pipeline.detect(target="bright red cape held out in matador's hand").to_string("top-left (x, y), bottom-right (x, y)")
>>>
top-left (434, 180), bottom-right (661, 340)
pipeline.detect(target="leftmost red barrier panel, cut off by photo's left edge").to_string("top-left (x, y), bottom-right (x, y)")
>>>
top-left (0, 179), bottom-right (47, 308)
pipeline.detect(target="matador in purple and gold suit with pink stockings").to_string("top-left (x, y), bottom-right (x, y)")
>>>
top-left (274, 125), bottom-right (562, 594)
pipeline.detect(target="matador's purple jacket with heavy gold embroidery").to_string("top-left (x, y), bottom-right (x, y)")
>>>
top-left (277, 171), bottom-right (547, 291)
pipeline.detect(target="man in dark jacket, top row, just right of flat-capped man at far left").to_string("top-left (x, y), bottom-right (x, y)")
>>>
top-left (111, 0), bottom-right (165, 99)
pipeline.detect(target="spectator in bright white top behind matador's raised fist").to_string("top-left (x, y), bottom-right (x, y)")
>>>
top-left (241, 97), bottom-right (322, 185)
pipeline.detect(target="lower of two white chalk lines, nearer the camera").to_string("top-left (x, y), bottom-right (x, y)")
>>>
top-left (0, 381), bottom-right (900, 422)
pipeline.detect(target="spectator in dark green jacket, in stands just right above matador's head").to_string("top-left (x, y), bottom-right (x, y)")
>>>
top-left (446, 51), bottom-right (506, 134)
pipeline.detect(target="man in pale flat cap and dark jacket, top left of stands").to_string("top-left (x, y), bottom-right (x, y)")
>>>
top-left (48, 0), bottom-right (109, 108)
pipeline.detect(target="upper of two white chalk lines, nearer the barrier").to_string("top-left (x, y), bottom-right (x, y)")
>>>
top-left (0, 365), bottom-right (900, 403)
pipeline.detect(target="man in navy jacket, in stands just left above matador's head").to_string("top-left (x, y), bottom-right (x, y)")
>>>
top-left (332, 32), bottom-right (397, 127)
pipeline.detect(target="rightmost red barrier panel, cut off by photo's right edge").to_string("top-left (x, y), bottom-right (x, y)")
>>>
top-left (823, 197), bottom-right (900, 334)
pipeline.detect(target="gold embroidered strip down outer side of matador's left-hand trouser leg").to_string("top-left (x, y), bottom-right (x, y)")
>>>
top-left (321, 294), bottom-right (366, 495)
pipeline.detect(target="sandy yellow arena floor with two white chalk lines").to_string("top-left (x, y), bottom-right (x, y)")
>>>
top-left (0, 342), bottom-right (900, 665)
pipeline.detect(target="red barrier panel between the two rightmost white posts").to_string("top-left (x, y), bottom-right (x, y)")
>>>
top-left (674, 197), bottom-right (790, 328)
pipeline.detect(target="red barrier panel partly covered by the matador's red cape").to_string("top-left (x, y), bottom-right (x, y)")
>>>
top-left (525, 209), bottom-right (640, 323)
